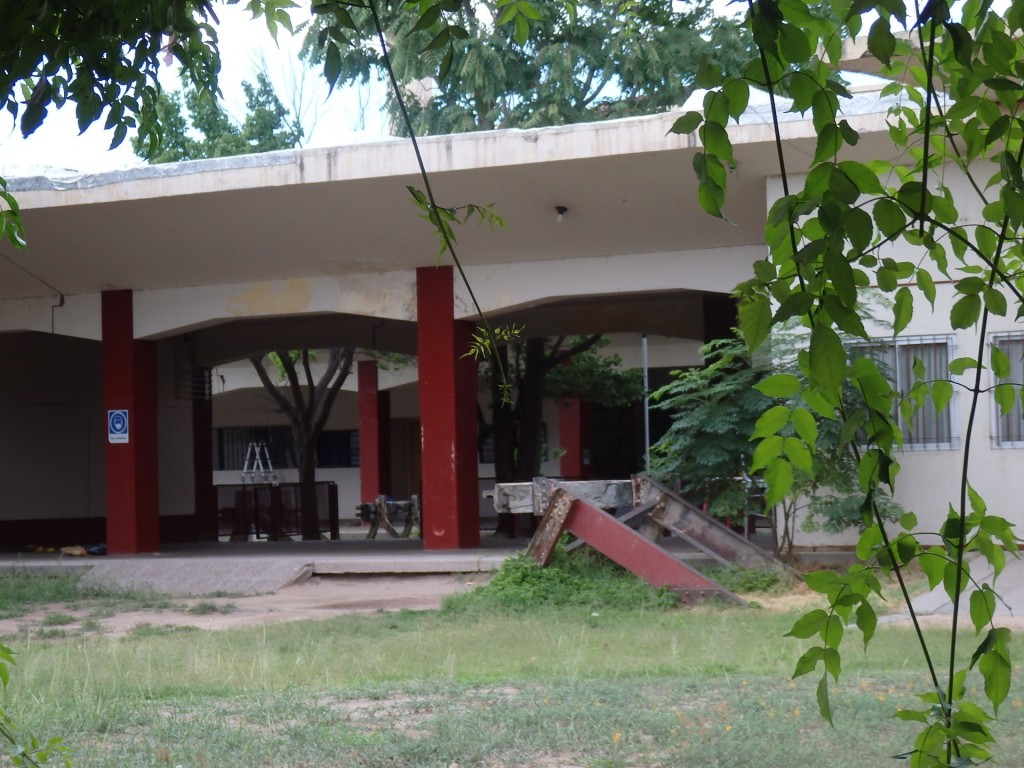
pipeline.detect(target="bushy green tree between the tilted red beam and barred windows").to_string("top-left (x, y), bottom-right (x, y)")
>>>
top-left (651, 331), bottom-right (902, 557)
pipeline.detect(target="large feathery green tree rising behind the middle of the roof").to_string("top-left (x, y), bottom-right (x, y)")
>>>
top-left (305, 0), bottom-right (750, 135)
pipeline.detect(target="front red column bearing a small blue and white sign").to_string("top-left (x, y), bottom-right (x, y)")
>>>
top-left (102, 291), bottom-right (160, 554)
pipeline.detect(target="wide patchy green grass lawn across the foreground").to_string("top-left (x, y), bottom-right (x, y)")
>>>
top-left (0, 561), bottom-right (1024, 768)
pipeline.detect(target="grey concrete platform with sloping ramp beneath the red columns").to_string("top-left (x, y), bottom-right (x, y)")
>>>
top-left (0, 539), bottom-right (527, 595)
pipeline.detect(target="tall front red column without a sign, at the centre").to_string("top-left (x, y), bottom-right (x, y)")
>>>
top-left (416, 266), bottom-right (480, 549)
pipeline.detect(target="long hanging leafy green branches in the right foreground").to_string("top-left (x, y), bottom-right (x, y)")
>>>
top-left (674, 0), bottom-right (1024, 766)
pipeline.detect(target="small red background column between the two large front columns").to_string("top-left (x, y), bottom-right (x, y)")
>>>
top-left (356, 360), bottom-right (391, 504)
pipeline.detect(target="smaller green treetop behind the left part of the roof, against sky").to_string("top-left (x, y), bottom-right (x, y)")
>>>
top-left (132, 72), bottom-right (303, 163)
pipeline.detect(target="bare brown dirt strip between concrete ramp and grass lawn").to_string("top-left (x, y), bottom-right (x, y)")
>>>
top-left (0, 573), bottom-right (490, 637)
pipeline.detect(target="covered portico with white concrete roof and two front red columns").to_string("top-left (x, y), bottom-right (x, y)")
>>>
top-left (0, 107), bottom-right (871, 552)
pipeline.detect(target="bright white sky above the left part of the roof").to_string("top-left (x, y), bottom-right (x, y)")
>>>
top-left (0, 5), bottom-right (386, 177)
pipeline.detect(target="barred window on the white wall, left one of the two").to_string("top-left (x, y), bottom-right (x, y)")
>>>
top-left (854, 336), bottom-right (958, 450)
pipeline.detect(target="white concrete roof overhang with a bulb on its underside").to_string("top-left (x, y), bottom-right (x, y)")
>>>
top-left (0, 94), bottom-right (893, 358)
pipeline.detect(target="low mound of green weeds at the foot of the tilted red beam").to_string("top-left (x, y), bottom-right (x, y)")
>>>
top-left (443, 547), bottom-right (679, 614)
